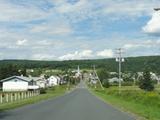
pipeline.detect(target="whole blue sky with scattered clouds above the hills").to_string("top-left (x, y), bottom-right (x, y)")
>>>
top-left (0, 0), bottom-right (160, 60)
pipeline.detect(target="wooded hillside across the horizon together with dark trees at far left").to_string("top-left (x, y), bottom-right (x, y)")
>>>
top-left (0, 56), bottom-right (160, 79)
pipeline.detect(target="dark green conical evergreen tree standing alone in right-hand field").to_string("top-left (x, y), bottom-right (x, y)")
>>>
top-left (139, 69), bottom-right (154, 91)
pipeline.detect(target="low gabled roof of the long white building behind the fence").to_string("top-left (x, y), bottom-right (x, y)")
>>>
top-left (1, 76), bottom-right (33, 82)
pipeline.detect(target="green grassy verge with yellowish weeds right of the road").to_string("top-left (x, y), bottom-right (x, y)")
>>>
top-left (92, 87), bottom-right (160, 120)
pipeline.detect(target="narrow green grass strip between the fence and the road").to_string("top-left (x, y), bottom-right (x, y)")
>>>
top-left (0, 86), bottom-right (66, 111)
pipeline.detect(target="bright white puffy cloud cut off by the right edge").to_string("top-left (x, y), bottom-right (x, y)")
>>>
top-left (143, 12), bottom-right (160, 36)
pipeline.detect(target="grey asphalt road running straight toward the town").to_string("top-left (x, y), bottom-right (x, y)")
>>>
top-left (0, 83), bottom-right (135, 120)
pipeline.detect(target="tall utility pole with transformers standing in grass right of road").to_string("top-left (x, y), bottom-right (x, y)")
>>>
top-left (116, 48), bottom-right (124, 93)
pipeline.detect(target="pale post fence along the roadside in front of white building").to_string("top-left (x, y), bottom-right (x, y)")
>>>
top-left (0, 90), bottom-right (40, 104)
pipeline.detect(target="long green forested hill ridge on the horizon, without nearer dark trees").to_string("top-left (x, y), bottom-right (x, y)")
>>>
top-left (0, 56), bottom-right (160, 73)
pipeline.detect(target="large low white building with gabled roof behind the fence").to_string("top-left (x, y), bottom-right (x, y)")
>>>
top-left (1, 76), bottom-right (39, 91)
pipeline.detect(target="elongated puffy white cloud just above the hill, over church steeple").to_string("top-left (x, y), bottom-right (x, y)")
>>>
top-left (59, 50), bottom-right (93, 60)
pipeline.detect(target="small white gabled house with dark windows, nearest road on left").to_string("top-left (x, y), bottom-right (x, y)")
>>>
top-left (47, 76), bottom-right (60, 87)
